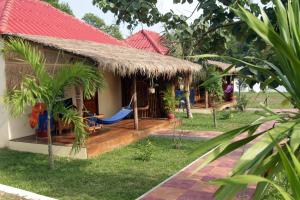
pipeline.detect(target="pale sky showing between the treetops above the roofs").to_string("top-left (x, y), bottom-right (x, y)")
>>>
top-left (61, 0), bottom-right (197, 38)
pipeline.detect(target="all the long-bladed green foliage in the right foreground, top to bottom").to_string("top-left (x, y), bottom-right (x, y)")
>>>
top-left (191, 0), bottom-right (300, 200)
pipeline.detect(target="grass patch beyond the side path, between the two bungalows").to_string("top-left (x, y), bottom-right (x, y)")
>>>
top-left (176, 111), bottom-right (259, 132)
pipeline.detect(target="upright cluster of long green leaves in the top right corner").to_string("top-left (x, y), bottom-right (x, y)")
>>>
top-left (233, 0), bottom-right (300, 108)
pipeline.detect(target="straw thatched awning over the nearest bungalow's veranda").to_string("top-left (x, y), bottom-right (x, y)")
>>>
top-left (5, 34), bottom-right (201, 77)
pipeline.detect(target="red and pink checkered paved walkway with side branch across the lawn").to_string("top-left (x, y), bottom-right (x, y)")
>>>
top-left (139, 123), bottom-right (273, 200)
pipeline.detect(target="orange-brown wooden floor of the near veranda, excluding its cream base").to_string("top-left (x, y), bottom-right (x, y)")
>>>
top-left (13, 119), bottom-right (181, 158)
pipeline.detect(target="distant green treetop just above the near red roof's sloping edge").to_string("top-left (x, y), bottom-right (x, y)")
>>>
top-left (82, 13), bottom-right (124, 40)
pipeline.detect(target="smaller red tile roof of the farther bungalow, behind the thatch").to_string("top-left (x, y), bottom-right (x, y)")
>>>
top-left (125, 30), bottom-right (169, 55)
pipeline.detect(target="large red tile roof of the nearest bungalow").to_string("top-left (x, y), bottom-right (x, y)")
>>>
top-left (0, 0), bottom-right (125, 46)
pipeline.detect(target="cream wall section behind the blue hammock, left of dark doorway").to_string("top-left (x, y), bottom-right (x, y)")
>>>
top-left (98, 72), bottom-right (122, 117)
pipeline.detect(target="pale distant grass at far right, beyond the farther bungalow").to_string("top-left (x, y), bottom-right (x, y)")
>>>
top-left (240, 92), bottom-right (293, 109)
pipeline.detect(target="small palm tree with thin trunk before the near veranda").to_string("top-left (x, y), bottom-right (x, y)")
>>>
top-left (4, 39), bottom-right (104, 169)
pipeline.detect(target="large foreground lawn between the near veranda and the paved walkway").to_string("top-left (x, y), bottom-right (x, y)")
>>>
top-left (0, 138), bottom-right (202, 200)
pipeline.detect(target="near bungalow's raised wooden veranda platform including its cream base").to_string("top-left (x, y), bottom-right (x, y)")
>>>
top-left (10, 119), bottom-right (181, 158)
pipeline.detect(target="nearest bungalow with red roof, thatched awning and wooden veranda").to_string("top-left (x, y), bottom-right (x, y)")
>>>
top-left (0, 0), bottom-right (201, 158)
